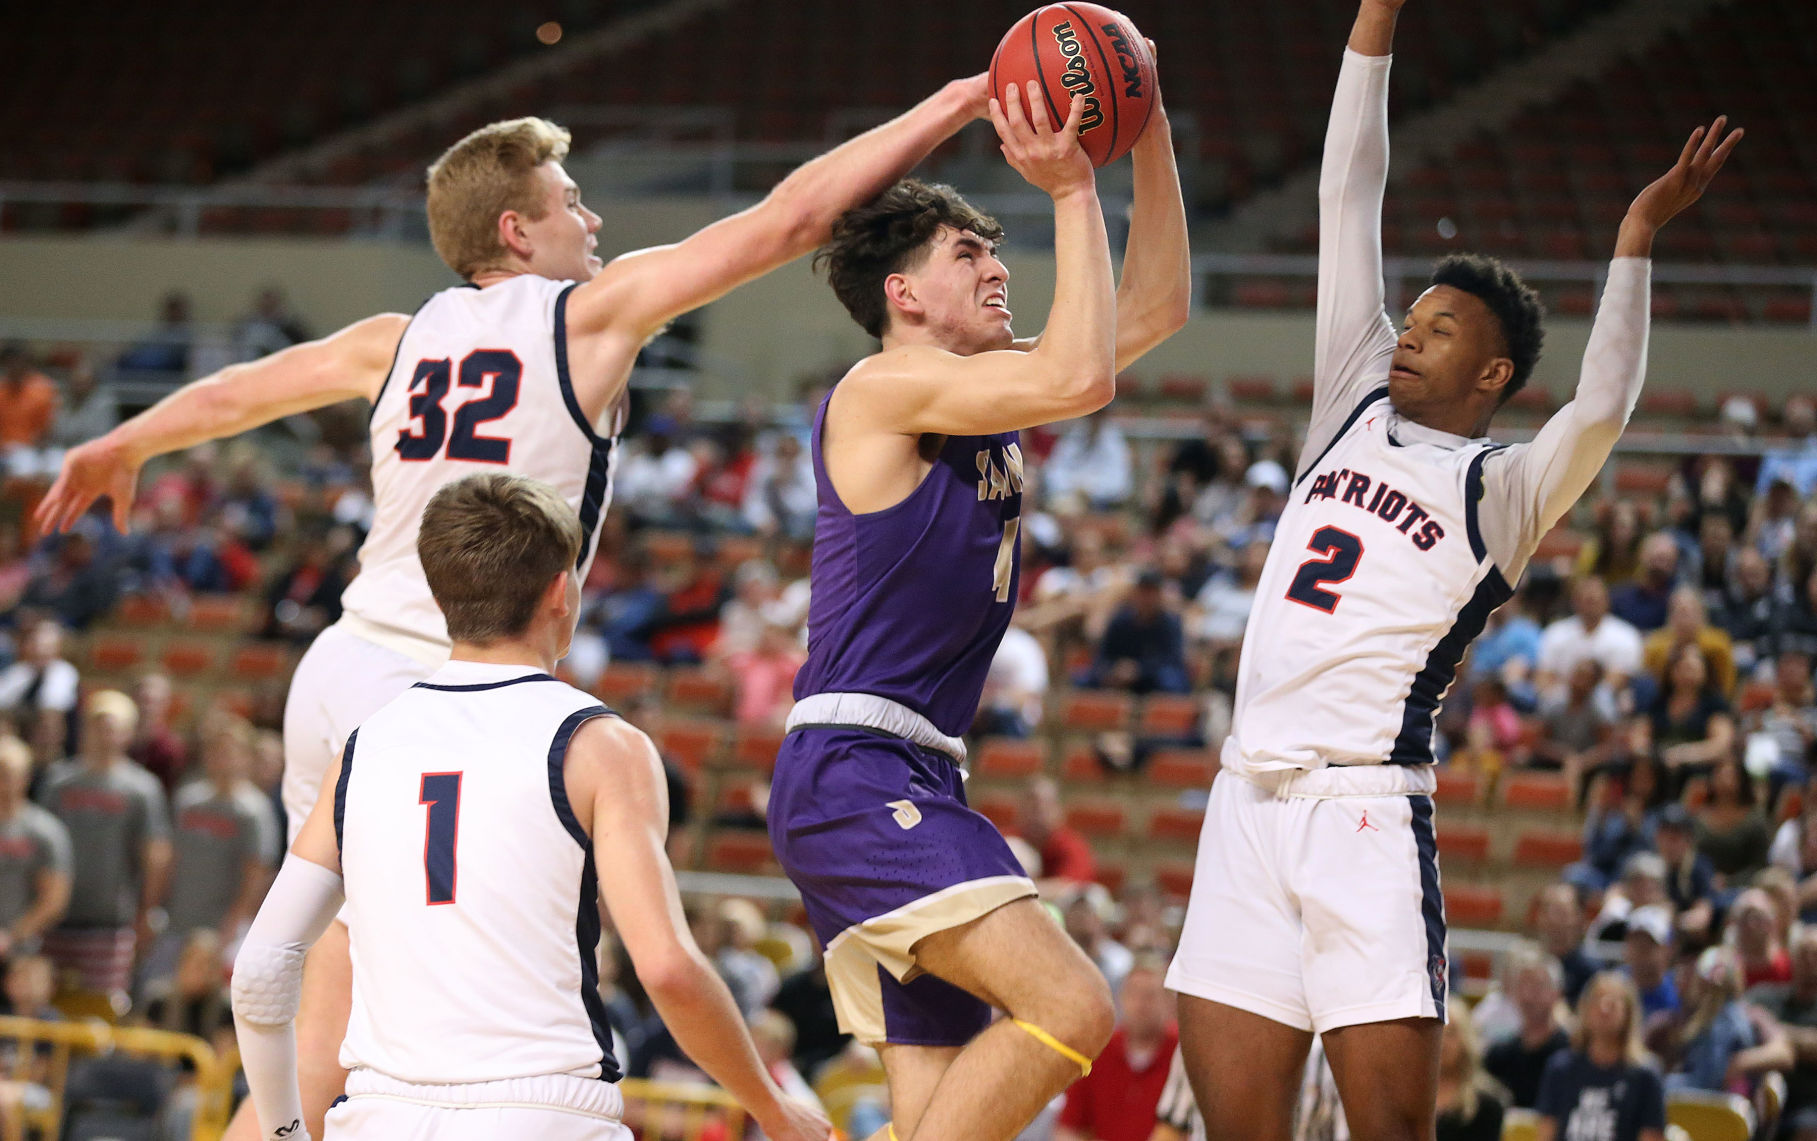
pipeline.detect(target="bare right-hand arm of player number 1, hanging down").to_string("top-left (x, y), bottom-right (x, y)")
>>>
top-left (563, 718), bottom-right (832, 1141)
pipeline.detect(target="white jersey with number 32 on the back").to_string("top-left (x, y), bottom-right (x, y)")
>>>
top-left (342, 274), bottom-right (616, 661)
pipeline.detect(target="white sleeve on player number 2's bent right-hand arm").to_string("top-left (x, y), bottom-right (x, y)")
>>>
top-left (1481, 258), bottom-right (1653, 570)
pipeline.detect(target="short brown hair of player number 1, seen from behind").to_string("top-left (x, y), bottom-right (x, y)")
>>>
top-left (416, 472), bottom-right (580, 645)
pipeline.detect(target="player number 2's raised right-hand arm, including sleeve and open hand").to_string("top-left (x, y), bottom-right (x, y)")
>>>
top-left (1484, 116), bottom-right (1743, 569)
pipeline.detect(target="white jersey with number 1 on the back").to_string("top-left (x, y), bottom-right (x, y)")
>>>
top-left (334, 661), bottom-right (620, 1085)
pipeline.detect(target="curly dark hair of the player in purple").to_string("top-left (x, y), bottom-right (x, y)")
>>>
top-left (814, 178), bottom-right (1003, 338)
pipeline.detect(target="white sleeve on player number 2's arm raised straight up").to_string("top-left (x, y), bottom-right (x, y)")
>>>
top-left (1299, 49), bottom-right (1395, 469)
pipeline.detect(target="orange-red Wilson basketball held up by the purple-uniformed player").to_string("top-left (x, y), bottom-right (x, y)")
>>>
top-left (990, 4), bottom-right (1156, 167)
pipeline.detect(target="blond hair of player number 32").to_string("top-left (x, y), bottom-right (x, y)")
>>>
top-left (429, 118), bottom-right (571, 278)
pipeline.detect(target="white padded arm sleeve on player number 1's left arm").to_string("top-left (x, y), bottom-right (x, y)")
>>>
top-left (233, 856), bottom-right (345, 1141)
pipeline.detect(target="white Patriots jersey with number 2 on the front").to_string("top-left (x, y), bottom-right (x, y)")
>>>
top-left (1223, 387), bottom-right (1512, 772)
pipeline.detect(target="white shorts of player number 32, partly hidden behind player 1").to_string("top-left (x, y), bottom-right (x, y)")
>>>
top-left (283, 625), bottom-right (434, 847)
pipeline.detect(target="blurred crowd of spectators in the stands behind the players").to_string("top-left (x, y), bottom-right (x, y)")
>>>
top-left (0, 317), bottom-right (1817, 1141)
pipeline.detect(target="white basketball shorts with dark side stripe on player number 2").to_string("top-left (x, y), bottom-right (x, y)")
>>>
top-left (1167, 765), bottom-right (1446, 1034)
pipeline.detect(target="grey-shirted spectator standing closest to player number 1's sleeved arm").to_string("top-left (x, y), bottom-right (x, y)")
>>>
top-left (145, 714), bottom-right (283, 979)
